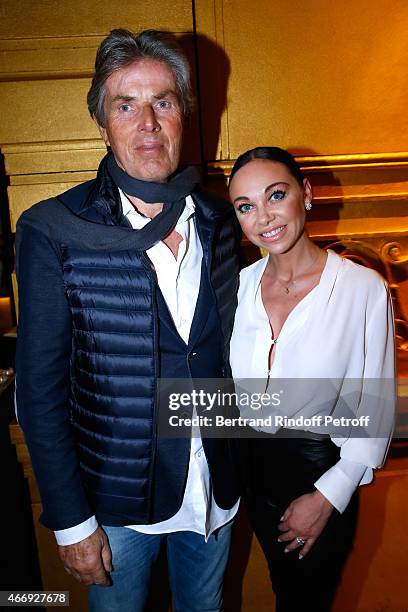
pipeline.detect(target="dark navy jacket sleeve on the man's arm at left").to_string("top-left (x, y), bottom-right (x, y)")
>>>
top-left (16, 220), bottom-right (93, 530)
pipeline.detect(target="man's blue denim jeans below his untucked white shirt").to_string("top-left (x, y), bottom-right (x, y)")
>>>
top-left (88, 522), bottom-right (232, 612)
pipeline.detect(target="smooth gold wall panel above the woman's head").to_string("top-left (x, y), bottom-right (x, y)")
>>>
top-left (196, 0), bottom-right (408, 159)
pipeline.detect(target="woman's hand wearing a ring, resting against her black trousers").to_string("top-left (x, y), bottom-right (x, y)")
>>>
top-left (278, 490), bottom-right (333, 559)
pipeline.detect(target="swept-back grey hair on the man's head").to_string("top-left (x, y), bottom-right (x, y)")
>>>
top-left (87, 28), bottom-right (193, 127)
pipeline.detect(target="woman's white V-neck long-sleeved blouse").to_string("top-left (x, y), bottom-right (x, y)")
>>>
top-left (230, 251), bottom-right (395, 512)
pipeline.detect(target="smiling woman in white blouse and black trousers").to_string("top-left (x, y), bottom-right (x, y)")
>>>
top-left (230, 147), bottom-right (395, 612)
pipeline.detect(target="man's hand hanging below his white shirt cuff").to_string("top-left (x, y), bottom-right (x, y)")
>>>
top-left (58, 527), bottom-right (112, 586)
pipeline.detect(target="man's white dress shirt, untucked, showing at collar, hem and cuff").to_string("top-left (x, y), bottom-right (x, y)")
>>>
top-left (55, 190), bottom-right (239, 546)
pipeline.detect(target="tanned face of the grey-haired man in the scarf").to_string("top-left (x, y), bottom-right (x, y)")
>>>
top-left (98, 59), bottom-right (183, 182)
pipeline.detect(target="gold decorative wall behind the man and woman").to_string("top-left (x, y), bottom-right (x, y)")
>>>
top-left (0, 0), bottom-right (408, 612)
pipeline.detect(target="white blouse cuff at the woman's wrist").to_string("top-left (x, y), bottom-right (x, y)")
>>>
top-left (314, 458), bottom-right (371, 512)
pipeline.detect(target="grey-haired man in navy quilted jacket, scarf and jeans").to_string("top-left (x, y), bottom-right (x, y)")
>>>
top-left (16, 29), bottom-right (239, 612)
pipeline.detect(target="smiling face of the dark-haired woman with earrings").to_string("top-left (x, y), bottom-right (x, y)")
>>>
top-left (230, 159), bottom-right (312, 255)
